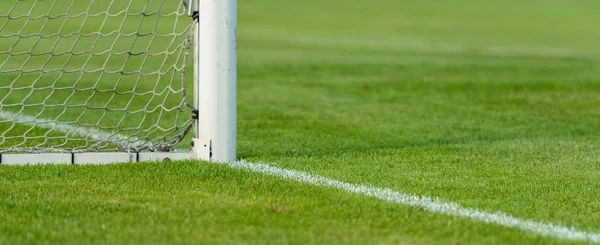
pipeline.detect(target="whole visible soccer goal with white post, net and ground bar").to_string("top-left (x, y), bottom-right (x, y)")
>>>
top-left (0, 0), bottom-right (237, 164)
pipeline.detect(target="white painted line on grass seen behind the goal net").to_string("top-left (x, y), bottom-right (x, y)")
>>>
top-left (0, 110), bottom-right (142, 146)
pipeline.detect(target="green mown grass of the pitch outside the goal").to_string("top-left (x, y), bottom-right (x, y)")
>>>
top-left (0, 0), bottom-right (600, 244)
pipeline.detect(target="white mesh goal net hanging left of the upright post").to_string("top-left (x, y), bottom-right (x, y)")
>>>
top-left (0, 0), bottom-right (193, 153)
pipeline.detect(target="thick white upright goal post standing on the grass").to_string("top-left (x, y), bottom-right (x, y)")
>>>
top-left (194, 0), bottom-right (237, 161)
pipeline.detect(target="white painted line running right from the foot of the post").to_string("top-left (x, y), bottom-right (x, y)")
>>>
top-left (218, 161), bottom-right (600, 243)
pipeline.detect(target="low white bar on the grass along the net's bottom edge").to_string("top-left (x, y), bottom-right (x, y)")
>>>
top-left (0, 152), bottom-right (200, 165)
